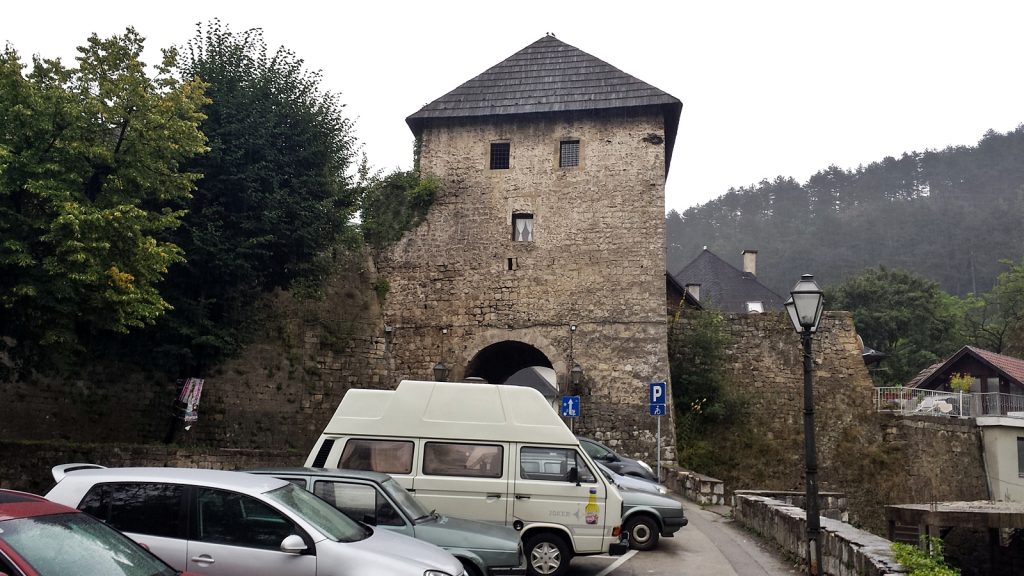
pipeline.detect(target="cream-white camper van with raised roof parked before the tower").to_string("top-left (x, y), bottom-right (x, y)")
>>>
top-left (306, 380), bottom-right (627, 576)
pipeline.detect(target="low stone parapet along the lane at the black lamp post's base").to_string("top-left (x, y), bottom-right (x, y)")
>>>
top-left (733, 494), bottom-right (907, 576)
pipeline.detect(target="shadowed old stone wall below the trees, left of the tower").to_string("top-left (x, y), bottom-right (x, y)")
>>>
top-left (0, 251), bottom-right (390, 453)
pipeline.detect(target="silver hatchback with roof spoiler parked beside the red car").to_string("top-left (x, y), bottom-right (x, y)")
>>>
top-left (46, 464), bottom-right (465, 576)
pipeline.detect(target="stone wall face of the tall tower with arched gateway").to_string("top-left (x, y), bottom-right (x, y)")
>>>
top-left (379, 111), bottom-right (674, 460)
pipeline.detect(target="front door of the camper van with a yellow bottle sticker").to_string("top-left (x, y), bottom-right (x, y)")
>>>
top-left (509, 445), bottom-right (608, 552)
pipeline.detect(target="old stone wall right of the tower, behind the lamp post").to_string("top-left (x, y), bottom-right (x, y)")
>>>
top-left (682, 312), bottom-right (988, 534)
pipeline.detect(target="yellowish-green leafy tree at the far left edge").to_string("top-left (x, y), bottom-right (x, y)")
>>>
top-left (0, 28), bottom-right (206, 366)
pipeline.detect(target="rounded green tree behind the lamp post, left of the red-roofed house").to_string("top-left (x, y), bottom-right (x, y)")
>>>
top-left (825, 266), bottom-right (964, 385)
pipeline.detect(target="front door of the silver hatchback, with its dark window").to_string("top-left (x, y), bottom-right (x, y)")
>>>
top-left (186, 488), bottom-right (316, 576)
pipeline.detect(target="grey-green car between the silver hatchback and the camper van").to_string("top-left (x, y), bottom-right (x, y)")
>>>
top-left (247, 468), bottom-right (526, 576)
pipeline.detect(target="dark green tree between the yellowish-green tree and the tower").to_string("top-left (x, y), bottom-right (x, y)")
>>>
top-left (148, 22), bottom-right (357, 369)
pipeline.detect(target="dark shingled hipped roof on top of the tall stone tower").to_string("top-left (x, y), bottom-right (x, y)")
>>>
top-left (406, 36), bottom-right (683, 169)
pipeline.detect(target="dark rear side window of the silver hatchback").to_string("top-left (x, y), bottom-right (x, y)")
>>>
top-left (78, 483), bottom-right (184, 538)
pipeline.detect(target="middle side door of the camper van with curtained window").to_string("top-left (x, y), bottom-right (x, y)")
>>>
top-left (415, 441), bottom-right (509, 524)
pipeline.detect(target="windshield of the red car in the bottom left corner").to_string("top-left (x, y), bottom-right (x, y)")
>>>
top-left (0, 513), bottom-right (177, 576)
